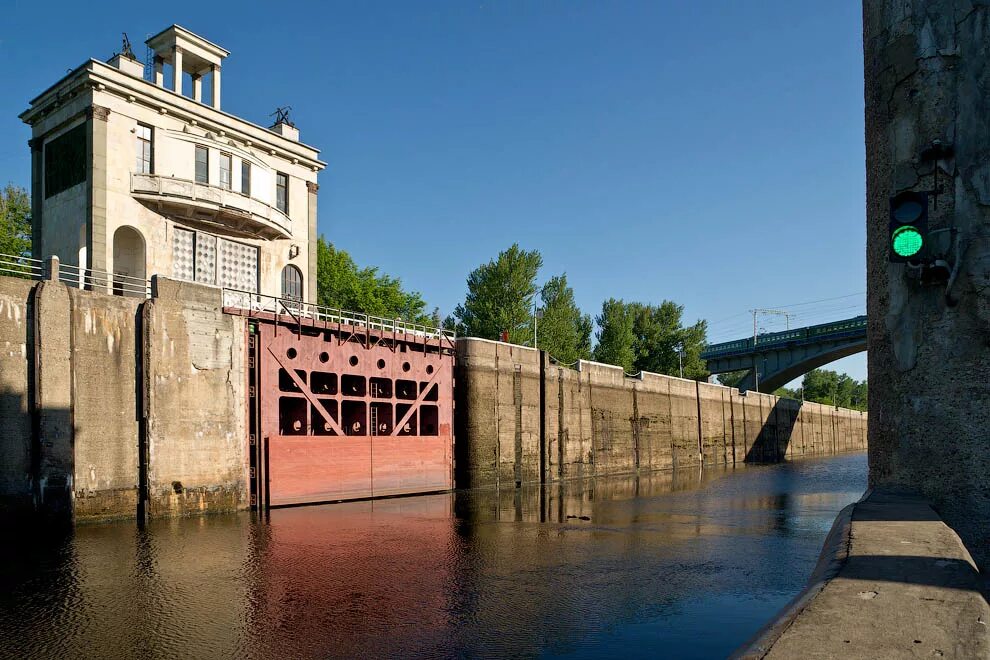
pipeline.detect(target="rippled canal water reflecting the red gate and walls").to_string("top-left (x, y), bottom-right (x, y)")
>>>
top-left (0, 454), bottom-right (866, 659)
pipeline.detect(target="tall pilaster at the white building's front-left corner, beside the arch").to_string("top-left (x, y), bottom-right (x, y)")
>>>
top-left (87, 105), bottom-right (110, 288)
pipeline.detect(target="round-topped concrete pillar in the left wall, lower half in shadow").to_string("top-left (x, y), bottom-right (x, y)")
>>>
top-left (34, 281), bottom-right (74, 518)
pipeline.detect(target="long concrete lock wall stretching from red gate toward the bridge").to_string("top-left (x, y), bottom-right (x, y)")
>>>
top-left (455, 338), bottom-right (867, 487)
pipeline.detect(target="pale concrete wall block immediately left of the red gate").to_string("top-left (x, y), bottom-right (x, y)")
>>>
top-left (143, 278), bottom-right (248, 516)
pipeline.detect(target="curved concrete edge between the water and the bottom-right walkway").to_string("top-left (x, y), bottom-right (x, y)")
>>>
top-left (729, 489), bottom-right (873, 660)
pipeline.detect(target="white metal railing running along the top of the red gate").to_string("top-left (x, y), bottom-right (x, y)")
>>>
top-left (223, 287), bottom-right (457, 341)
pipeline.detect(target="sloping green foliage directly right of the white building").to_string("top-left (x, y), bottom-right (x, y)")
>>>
top-left (316, 236), bottom-right (430, 325)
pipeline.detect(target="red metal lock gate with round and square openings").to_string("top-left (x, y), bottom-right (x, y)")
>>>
top-left (255, 315), bottom-right (454, 506)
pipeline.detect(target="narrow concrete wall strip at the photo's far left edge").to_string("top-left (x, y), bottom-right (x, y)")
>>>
top-left (0, 277), bottom-right (34, 513)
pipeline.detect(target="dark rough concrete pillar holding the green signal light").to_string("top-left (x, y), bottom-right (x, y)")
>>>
top-left (863, 0), bottom-right (990, 570)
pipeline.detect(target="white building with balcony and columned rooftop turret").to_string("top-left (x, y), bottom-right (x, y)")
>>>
top-left (21, 25), bottom-right (326, 302)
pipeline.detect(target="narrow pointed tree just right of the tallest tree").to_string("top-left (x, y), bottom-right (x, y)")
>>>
top-left (536, 275), bottom-right (591, 364)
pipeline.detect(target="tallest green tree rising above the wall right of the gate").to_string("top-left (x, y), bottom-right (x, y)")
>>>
top-left (454, 243), bottom-right (543, 344)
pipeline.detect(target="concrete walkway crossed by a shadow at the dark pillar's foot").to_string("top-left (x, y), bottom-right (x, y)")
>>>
top-left (739, 491), bottom-right (990, 658)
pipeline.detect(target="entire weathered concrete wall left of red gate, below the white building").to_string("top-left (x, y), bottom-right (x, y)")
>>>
top-left (0, 277), bottom-right (248, 521)
